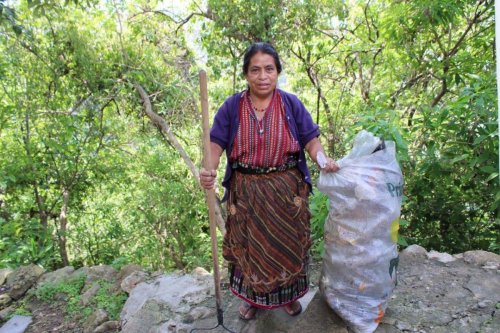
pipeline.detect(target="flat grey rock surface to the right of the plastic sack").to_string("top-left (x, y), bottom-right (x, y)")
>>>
top-left (376, 249), bottom-right (500, 333)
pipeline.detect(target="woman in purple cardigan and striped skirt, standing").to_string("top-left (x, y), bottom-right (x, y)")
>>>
top-left (200, 43), bottom-right (338, 320)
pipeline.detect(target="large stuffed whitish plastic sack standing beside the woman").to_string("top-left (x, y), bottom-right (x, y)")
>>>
top-left (318, 131), bottom-right (403, 333)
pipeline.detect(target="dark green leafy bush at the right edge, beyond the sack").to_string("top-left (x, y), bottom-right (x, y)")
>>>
top-left (406, 76), bottom-right (500, 252)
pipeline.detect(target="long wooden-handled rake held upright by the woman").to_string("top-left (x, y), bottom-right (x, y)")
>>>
top-left (191, 70), bottom-right (234, 333)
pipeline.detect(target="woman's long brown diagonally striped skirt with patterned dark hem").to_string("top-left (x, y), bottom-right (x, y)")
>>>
top-left (223, 168), bottom-right (311, 309)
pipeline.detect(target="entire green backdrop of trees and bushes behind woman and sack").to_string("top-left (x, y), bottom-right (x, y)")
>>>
top-left (0, 0), bottom-right (500, 269)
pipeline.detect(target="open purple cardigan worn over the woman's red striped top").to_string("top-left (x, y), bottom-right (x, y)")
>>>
top-left (210, 90), bottom-right (319, 201)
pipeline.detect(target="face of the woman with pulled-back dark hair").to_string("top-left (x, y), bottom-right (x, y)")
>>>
top-left (245, 52), bottom-right (278, 98)
